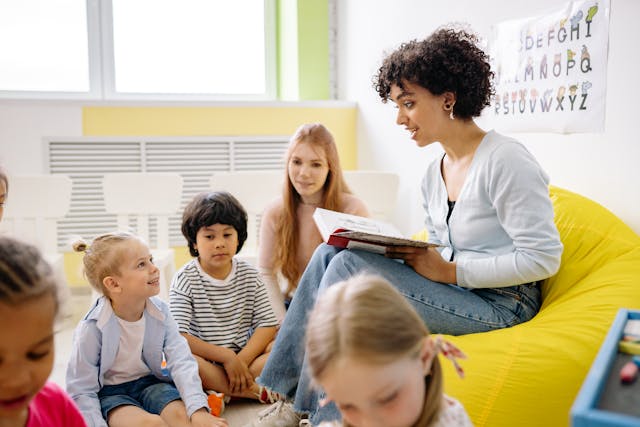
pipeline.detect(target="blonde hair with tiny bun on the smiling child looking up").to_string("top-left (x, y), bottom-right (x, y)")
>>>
top-left (72, 231), bottom-right (142, 296)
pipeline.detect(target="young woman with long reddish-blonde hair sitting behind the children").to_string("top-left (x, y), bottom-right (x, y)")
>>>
top-left (258, 123), bottom-right (369, 318)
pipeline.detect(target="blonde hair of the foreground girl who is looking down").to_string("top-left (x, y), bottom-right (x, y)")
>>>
top-left (306, 275), bottom-right (443, 427)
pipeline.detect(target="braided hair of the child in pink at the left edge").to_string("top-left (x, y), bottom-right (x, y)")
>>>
top-left (0, 236), bottom-right (61, 314)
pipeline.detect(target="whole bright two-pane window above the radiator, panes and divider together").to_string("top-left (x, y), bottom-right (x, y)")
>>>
top-left (0, 0), bottom-right (276, 100)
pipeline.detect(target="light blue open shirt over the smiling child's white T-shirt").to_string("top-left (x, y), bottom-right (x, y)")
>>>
top-left (66, 296), bottom-right (209, 427)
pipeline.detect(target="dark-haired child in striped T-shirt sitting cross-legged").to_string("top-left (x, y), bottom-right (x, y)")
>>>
top-left (169, 191), bottom-right (278, 403)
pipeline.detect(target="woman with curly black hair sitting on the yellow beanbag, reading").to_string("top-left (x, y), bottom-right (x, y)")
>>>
top-left (248, 28), bottom-right (562, 427)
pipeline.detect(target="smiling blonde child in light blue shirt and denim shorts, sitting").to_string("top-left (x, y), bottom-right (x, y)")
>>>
top-left (67, 233), bottom-right (227, 427)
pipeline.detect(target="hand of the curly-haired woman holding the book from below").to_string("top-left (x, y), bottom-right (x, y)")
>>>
top-left (385, 246), bottom-right (458, 283)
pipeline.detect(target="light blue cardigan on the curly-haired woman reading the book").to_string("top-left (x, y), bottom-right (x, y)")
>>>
top-left (422, 131), bottom-right (562, 288)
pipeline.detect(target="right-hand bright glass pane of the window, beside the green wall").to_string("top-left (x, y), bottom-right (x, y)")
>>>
top-left (107, 0), bottom-right (269, 98)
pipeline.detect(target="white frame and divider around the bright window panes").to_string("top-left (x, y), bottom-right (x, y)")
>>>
top-left (0, 0), bottom-right (277, 102)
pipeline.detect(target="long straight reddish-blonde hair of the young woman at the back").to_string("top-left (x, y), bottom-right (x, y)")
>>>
top-left (274, 123), bottom-right (351, 293)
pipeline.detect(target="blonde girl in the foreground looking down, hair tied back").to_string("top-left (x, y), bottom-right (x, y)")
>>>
top-left (306, 275), bottom-right (471, 427)
